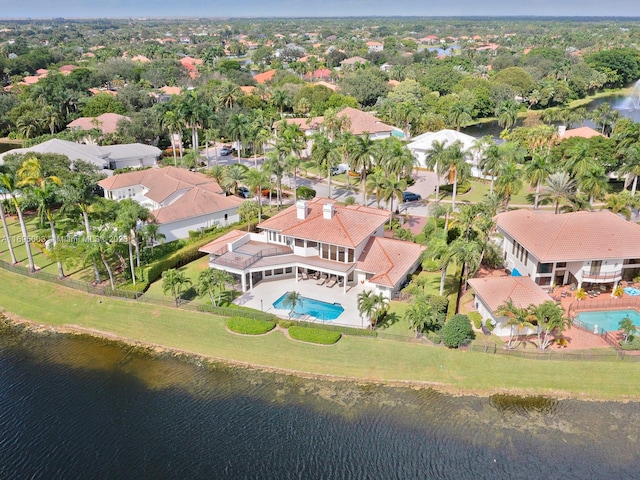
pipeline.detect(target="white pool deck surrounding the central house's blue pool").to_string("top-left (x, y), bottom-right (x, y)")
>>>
top-left (233, 277), bottom-right (366, 328)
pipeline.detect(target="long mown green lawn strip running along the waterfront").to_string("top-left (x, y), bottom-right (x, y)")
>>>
top-left (0, 270), bottom-right (640, 399)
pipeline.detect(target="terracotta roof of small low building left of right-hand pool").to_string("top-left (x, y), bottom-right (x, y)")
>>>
top-left (469, 277), bottom-right (553, 312)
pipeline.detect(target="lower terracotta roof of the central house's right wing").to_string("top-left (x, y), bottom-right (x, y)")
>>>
top-left (357, 237), bottom-right (426, 287)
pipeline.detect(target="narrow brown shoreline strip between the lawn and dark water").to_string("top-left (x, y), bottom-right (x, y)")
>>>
top-left (0, 309), bottom-right (640, 403)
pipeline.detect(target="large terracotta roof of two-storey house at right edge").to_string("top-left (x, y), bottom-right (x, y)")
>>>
top-left (496, 209), bottom-right (640, 263)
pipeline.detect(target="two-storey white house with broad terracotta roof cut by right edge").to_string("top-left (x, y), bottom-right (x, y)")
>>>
top-left (496, 209), bottom-right (640, 289)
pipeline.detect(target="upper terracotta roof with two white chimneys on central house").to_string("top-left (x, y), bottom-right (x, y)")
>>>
top-left (258, 197), bottom-right (390, 247)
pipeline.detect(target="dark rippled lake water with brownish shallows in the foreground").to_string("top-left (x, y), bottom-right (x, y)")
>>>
top-left (0, 322), bottom-right (640, 479)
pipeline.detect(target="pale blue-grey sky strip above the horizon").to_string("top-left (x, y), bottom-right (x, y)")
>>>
top-left (0, 0), bottom-right (640, 18)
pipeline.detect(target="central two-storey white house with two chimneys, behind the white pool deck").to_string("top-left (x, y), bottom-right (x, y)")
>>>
top-left (200, 197), bottom-right (425, 298)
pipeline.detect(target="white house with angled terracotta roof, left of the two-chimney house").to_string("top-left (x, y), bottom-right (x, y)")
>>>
top-left (98, 167), bottom-right (242, 242)
